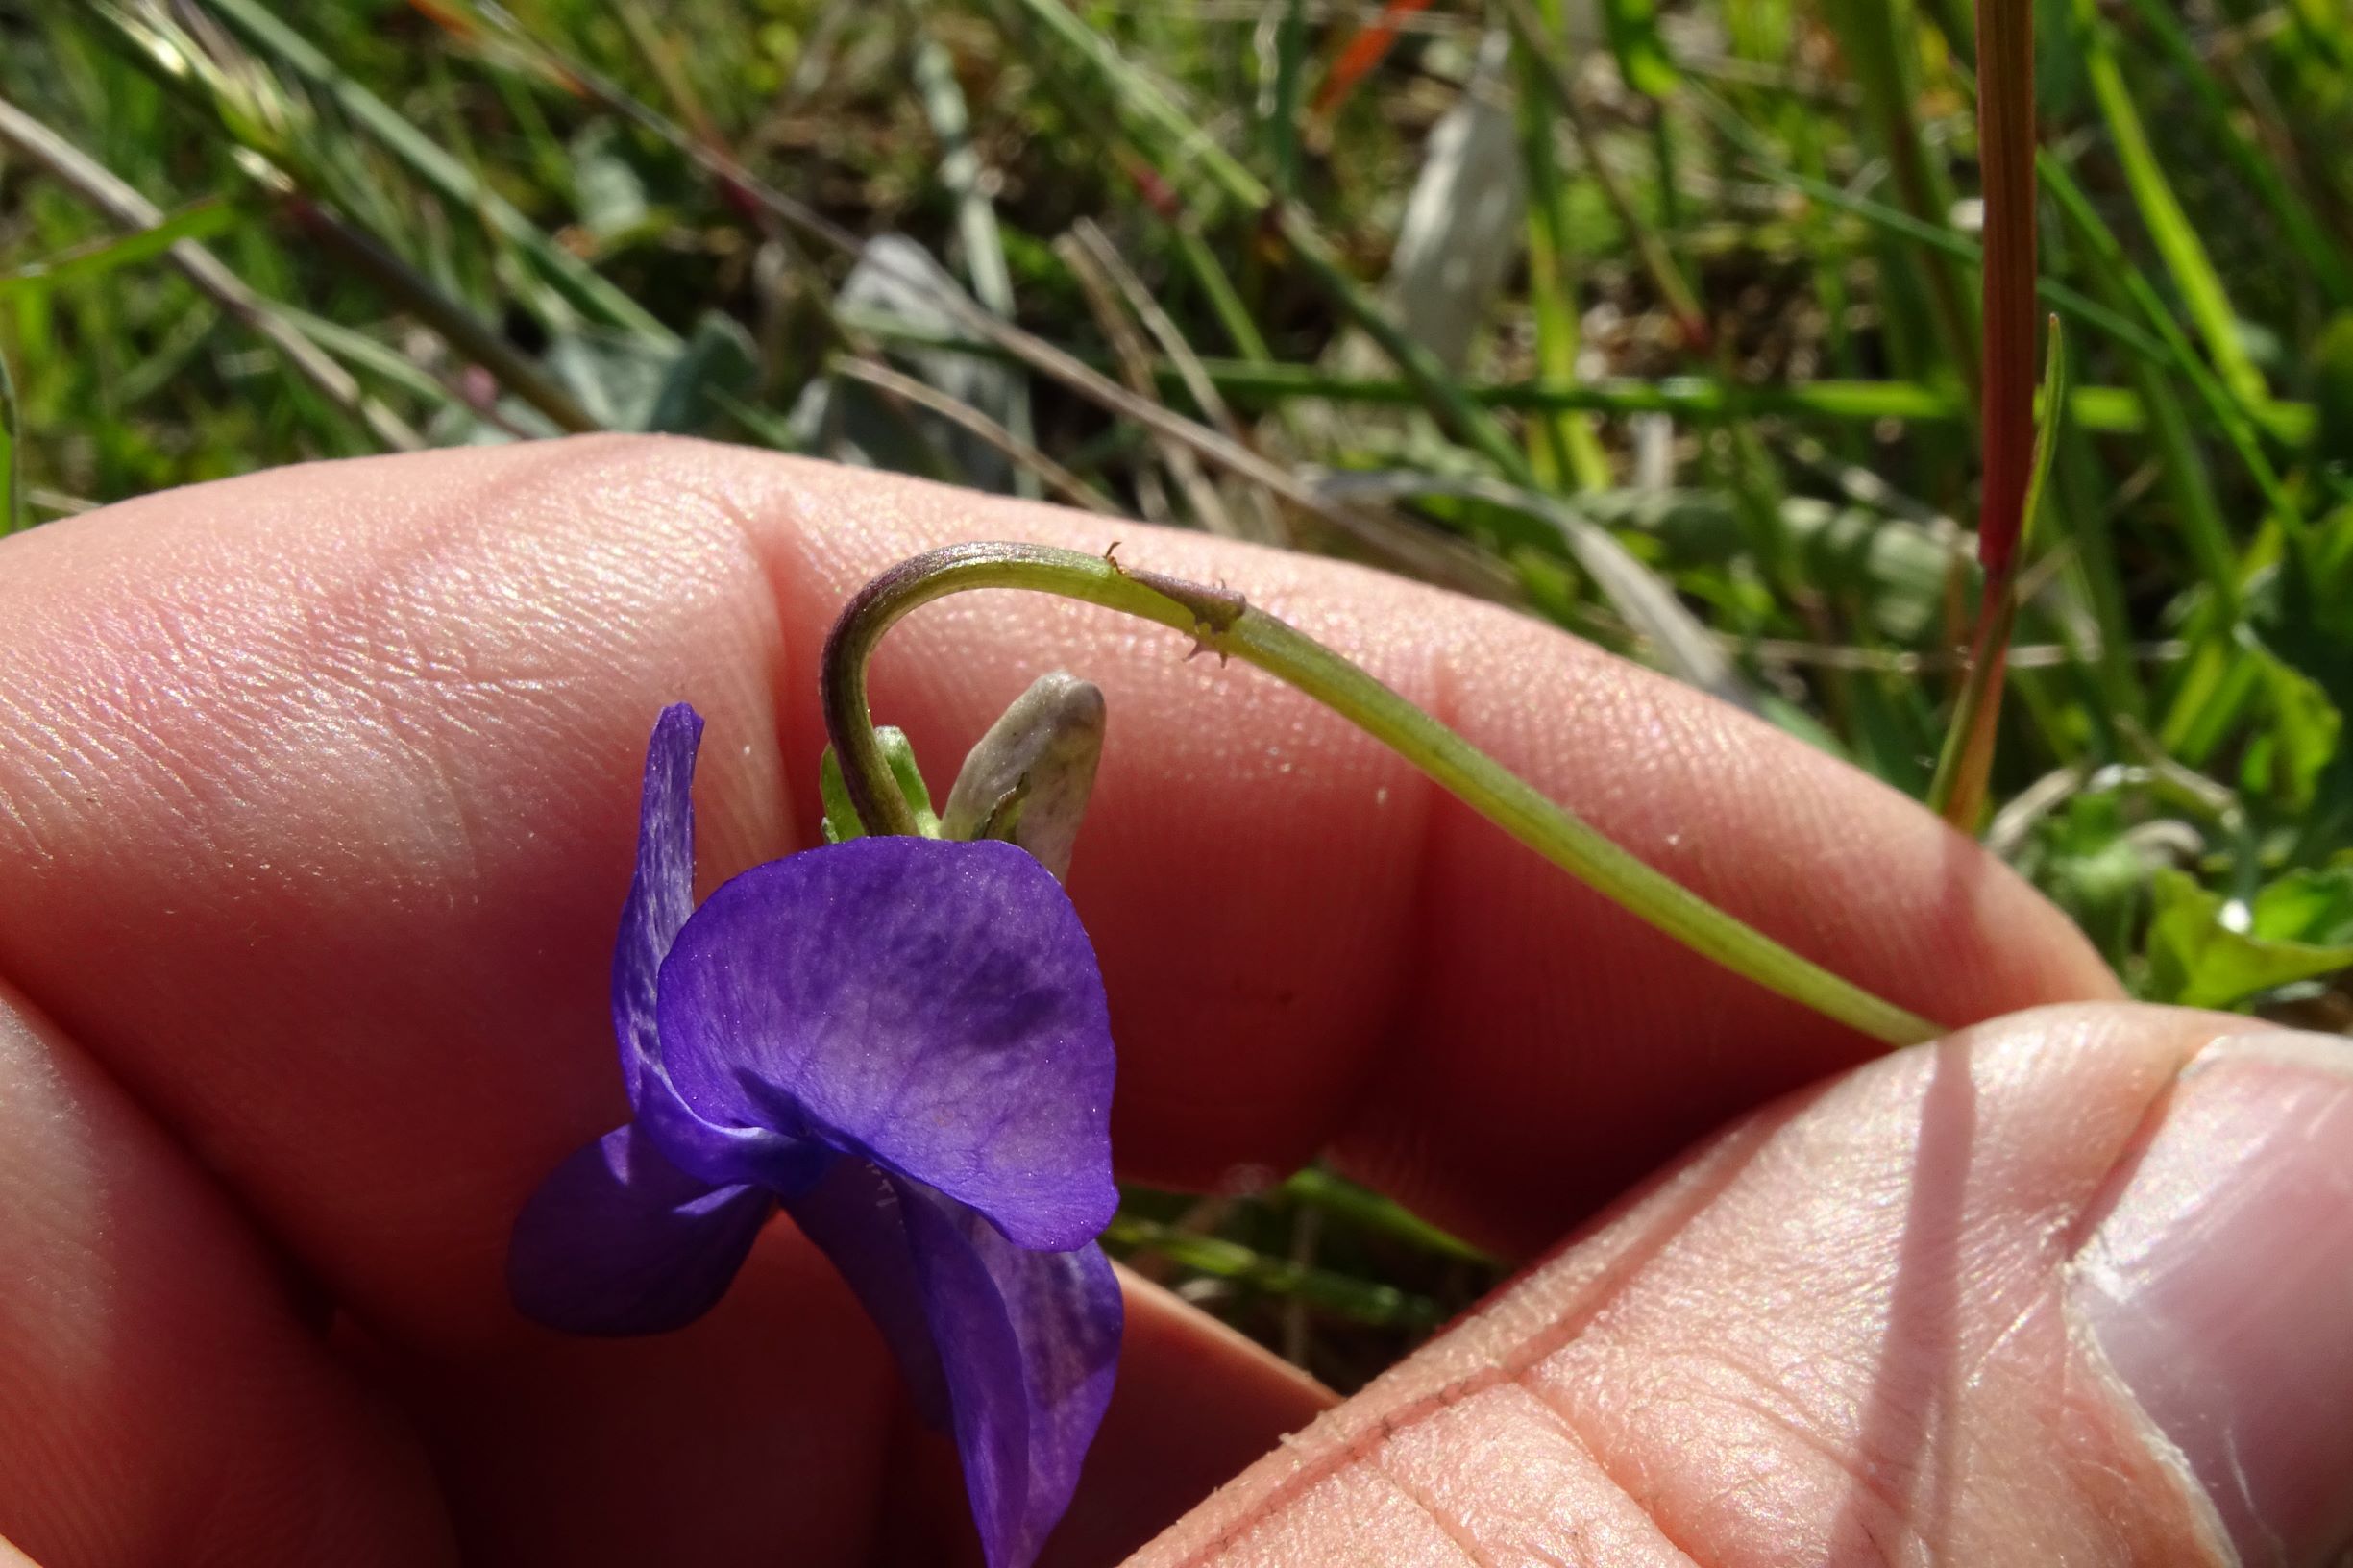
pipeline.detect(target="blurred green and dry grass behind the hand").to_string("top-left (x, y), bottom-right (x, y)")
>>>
top-left (0, 0), bottom-right (2353, 1384)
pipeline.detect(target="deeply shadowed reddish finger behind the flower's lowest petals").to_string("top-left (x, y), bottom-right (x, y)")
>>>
top-left (364, 1224), bottom-right (1332, 1568)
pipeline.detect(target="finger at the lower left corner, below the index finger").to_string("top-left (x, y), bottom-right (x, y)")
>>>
top-left (0, 987), bottom-right (454, 1568)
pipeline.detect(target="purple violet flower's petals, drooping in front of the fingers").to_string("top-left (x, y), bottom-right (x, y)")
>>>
top-left (508, 704), bottom-right (1120, 1568)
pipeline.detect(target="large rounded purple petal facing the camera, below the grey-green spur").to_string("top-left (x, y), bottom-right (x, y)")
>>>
top-left (656, 838), bottom-right (1117, 1250)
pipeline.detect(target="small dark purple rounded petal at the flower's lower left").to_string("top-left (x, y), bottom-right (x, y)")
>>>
top-left (506, 1123), bottom-right (774, 1335)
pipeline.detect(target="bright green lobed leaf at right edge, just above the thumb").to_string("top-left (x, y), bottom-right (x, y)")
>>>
top-left (2144, 867), bottom-right (2353, 1008)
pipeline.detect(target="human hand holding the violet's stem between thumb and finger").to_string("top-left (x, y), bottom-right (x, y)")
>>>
top-left (0, 443), bottom-right (2353, 1568)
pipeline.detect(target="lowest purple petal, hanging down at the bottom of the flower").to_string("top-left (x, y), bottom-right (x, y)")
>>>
top-left (892, 1180), bottom-right (1122, 1568)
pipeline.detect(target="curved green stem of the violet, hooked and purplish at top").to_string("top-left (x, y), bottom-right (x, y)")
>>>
top-left (823, 544), bottom-right (1944, 1045)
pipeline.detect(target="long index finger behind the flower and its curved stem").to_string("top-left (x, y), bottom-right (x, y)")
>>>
top-left (0, 443), bottom-right (2108, 1339)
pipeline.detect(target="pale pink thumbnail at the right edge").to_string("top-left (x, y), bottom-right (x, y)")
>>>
top-left (2071, 1031), bottom-right (2353, 1568)
